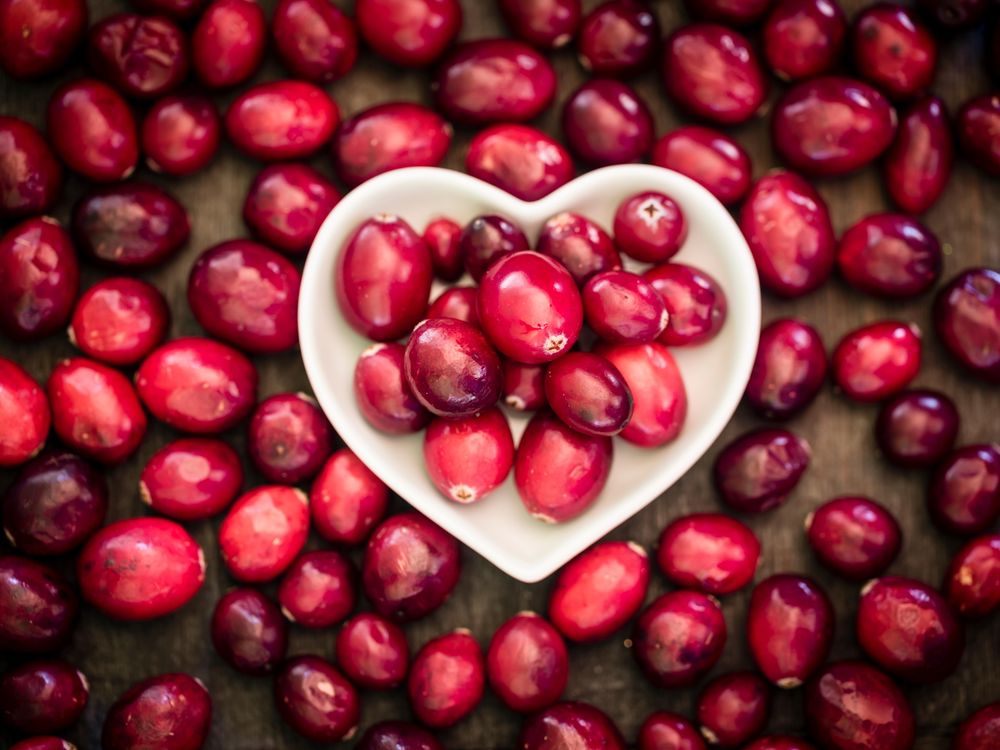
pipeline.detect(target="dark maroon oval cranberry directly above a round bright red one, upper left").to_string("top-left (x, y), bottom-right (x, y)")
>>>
top-left (72, 183), bottom-right (191, 270)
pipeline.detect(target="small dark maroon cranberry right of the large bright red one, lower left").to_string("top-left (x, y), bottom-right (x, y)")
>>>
top-left (211, 588), bottom-right (288, 675)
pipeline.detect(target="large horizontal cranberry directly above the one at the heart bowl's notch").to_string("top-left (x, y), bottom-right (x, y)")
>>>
top-left (432, 39), bottom-right (556, 125)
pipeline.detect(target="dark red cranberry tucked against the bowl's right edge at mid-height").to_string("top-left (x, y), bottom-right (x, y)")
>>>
top-left (746, 318), bottom-right (826, 419)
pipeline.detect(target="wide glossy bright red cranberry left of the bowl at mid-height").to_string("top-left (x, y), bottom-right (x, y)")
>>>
top-left (135, 336), bottom-right (257, 434)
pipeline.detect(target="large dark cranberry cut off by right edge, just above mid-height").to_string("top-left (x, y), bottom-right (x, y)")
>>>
top-left (934, 268), bottom-right (1000, 383)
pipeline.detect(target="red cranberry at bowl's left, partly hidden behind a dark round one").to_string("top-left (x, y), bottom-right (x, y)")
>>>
top-left (354, 342), bottom-right (431, 434)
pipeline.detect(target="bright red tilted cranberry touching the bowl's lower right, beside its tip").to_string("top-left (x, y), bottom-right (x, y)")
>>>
top-left (548, 542), bottom-right (649, 643)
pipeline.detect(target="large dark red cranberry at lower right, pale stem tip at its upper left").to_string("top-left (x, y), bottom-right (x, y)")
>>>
top-left (857, 576), bottom-right (965, 683)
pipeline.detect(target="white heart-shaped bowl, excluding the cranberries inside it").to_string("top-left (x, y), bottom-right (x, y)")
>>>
top-left (299, 164), bottom-right (760, 583)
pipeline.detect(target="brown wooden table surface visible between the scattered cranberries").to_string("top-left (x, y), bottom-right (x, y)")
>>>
top-left (0, 0), bottom-right (1000, 750)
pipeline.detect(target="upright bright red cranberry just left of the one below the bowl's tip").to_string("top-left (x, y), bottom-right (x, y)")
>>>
top-left (407, 630), bottom-right (486, 729)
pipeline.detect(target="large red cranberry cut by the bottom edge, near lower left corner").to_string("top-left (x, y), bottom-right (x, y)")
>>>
top-left (101, 674), bottom-right (212, 750)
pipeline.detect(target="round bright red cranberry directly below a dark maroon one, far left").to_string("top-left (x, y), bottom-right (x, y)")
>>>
top-left (69, 276), bottom-right (170, 365)
